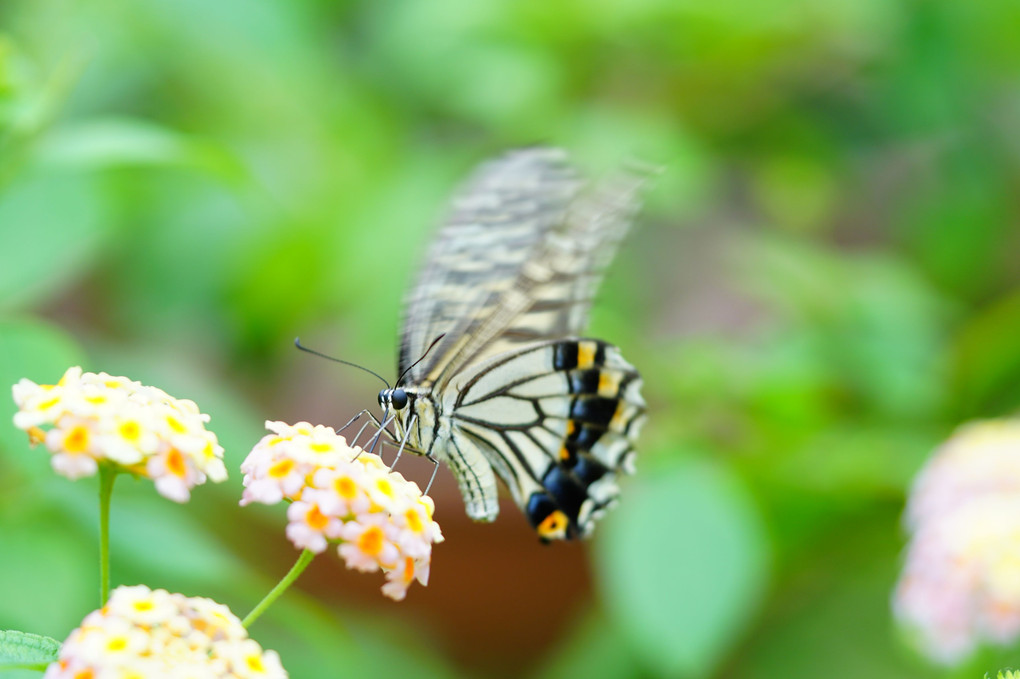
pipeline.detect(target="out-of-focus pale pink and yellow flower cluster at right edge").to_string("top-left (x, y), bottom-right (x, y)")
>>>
top-left (894, 421), bottom-right (1020, 664)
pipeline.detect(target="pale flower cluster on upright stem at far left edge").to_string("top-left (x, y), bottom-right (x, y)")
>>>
top-left (12, 367), bottom-right (226, 502)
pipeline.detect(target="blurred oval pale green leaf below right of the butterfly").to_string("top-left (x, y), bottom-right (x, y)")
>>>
top-left (598, 462), bottom-right (769, 677)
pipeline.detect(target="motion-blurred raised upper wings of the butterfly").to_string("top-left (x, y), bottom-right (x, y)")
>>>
top-left (398, 148), bottom-right (645, 388)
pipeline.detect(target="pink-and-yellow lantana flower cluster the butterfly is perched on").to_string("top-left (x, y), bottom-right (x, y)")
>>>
top-left (241, 422), bottom-right (443, 600)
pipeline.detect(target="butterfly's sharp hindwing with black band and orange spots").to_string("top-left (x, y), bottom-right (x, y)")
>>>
top-left (450, 338), bottom-right (645, 539)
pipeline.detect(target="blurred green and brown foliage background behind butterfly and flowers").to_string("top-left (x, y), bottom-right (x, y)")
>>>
top-left (0, 0), bottom-right (1020, 679)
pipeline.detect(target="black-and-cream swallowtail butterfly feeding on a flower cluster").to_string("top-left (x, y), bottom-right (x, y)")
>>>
top-left (373, 148), bottom-right (646, 541)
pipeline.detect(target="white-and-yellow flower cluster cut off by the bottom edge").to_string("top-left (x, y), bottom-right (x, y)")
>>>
top-left (44, 585), bottom-right (287, 679)
